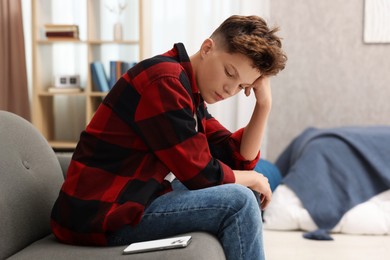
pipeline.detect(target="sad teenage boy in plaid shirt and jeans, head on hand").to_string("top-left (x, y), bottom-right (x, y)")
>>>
top-left (51, 15), bottom-right (286, 259)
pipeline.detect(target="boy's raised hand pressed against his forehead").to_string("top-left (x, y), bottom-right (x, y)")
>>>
top-left (245, 76), bottom-right (272, 108)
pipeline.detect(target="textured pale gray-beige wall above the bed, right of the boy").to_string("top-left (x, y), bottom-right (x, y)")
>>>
top-left (268, 0), bottom-right (390, 160)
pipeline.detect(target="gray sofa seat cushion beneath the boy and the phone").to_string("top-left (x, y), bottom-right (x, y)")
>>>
top-left (9, 232), bottom-right (225, 260)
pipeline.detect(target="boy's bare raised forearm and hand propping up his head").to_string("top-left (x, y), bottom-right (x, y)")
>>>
top-left (240, 77), bottom-right (272, 160)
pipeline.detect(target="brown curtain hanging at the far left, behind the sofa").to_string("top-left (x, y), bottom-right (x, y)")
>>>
top-left (0, 0), bottom-right (31, 120)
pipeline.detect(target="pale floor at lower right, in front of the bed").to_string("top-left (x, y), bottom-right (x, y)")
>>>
top-left (264, 230), bottom-right (390, 260)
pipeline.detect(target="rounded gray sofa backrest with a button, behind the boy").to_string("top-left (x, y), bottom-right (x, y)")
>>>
top-left (0, 111), bottom-right (64, 259)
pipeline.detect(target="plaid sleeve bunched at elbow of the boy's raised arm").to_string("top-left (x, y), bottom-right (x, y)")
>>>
top-left (205, 105), bottom-right (260, 170)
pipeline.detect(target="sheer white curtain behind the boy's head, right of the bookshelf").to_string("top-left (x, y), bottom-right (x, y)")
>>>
top-left (144, 0), bottom-right (270, 156)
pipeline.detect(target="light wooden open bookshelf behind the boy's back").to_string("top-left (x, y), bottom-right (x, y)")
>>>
top-left (31, 0), bottom-right (143, 150)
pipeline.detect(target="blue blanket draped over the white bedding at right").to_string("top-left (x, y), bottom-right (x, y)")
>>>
top-left (276, 126), bottom-right (390, 230)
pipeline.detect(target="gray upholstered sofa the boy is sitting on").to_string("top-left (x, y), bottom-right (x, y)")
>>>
top-left (0, 111), bottom-right (225, 260)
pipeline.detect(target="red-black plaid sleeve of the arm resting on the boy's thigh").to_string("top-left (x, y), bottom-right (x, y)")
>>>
top-left (135, 77), bottom-right (235, 189)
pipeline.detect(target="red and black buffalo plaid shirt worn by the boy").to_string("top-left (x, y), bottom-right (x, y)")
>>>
top-left (51, 43), bottom-right (259, 245)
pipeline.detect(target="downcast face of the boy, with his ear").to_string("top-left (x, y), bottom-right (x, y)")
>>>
top-left (195, 39), bottom-right (261, 104)
